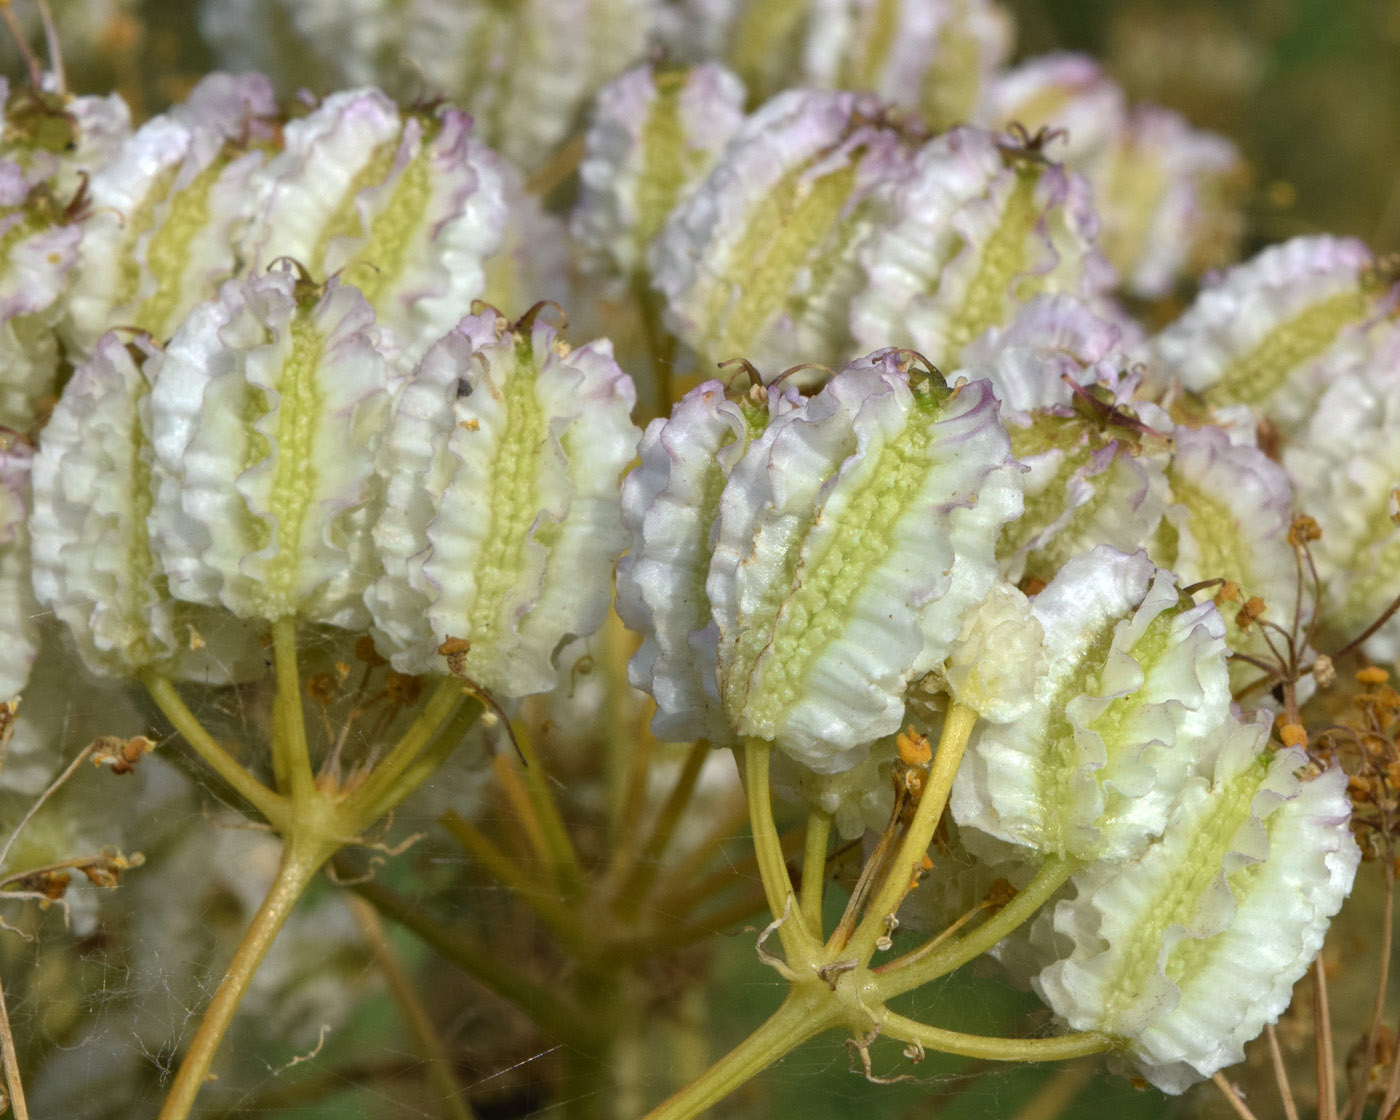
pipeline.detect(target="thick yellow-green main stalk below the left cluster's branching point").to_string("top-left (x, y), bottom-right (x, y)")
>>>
top-left (158, 839), bottom-right (336, 1120)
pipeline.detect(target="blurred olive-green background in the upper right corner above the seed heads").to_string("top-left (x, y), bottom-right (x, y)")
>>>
top-left (1008, 0), bottom-right (1400, 252)
